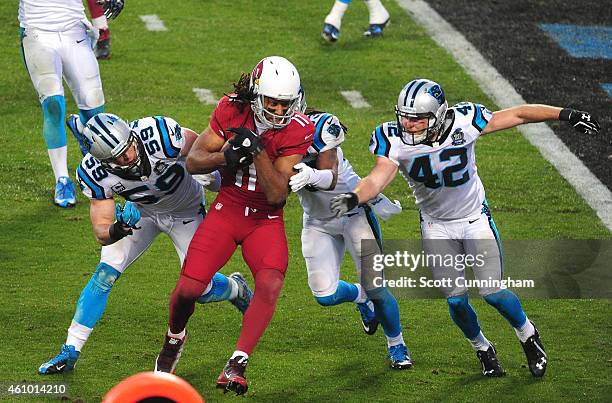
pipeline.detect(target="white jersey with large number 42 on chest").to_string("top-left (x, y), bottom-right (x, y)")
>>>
top-left (370, 102), bottom-right (493, 220)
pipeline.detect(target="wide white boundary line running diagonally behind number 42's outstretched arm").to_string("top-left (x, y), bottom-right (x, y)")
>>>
top-left (396, 0), bottom-right (612, 231)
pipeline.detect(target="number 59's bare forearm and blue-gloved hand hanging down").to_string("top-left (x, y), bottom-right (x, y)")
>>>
top-left (89, 199), bottom-right (140, 245)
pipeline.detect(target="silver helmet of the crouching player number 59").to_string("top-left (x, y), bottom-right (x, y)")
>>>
top-left (83, 113), bottom-right (151, 179)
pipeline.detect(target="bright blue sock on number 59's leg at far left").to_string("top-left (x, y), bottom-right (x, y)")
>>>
top-left (73, 263), bottom-right (121, 328)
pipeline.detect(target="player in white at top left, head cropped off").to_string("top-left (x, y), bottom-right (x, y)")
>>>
top-left (19, 0), bottom-right (123, 208)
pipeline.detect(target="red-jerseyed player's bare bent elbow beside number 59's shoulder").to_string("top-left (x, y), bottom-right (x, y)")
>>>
top-left (185, 126), bottom-right (225, 174)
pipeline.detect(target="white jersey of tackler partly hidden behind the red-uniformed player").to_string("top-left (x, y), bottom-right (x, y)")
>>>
top-left (297, 113), bottom-right (360, 218)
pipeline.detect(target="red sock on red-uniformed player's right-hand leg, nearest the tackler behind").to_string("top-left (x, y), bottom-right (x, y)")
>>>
top-left (236, 269), bottom-right (285, 355)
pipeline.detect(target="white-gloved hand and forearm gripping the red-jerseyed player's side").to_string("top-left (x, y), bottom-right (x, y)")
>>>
top-left (289, 148), bottom-right (338, 192)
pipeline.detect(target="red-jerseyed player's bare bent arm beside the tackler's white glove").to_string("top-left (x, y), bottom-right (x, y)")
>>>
top-left (254, 152), bottom-right (302, 207)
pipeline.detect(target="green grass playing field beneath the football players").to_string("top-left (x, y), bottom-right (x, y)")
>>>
top-left (0, 0), bottom-right (612, 402)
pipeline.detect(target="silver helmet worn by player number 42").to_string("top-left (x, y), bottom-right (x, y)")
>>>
top-left (395, 79), bottom-right (448, 145)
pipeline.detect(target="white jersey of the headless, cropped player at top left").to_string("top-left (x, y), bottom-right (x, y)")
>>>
top-left (18, 0), bottom-right (85, 32)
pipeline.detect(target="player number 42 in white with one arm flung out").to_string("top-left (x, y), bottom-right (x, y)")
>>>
top-left (331, 79), bottom-right (599, 377)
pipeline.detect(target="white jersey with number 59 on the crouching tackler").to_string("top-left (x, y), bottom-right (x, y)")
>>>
top-left (77, 116), bottom-right (204, 215)
